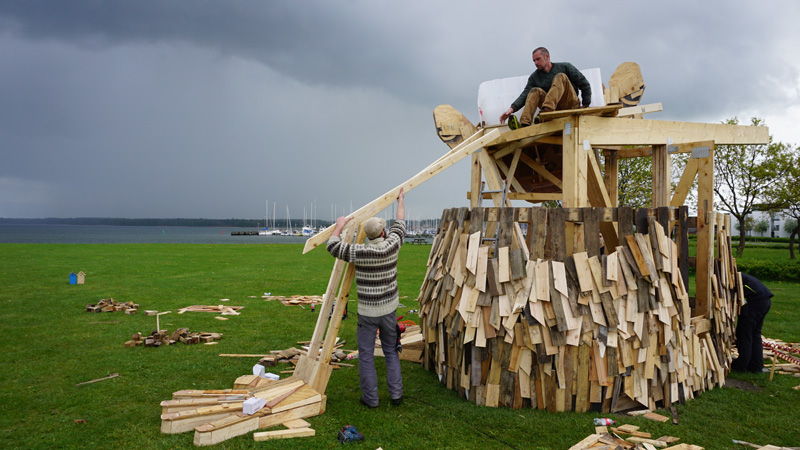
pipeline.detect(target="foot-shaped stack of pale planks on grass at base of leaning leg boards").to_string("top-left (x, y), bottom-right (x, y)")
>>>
top-left (161, 375), bottom-right (326, 446)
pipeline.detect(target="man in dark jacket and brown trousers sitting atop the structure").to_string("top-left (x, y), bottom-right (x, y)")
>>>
top-left (500, 47), bottom-right (592, 130)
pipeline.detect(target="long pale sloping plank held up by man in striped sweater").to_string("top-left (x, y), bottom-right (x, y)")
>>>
top-left (303, 129), bottom-right (500, 253)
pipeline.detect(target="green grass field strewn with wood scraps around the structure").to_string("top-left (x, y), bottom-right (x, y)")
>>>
top-left (0, 244), bottom-right (800, 450)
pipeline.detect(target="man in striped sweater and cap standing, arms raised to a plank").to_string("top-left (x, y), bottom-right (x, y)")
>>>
top-left (327, 188), bottom-right (406, 408)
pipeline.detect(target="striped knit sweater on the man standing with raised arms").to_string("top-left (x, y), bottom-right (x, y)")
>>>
top-left (327, 220), bottom-right (406, 317)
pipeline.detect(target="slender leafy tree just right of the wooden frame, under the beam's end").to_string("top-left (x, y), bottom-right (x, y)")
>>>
top-left (714, 117), bottom-right (790, 256)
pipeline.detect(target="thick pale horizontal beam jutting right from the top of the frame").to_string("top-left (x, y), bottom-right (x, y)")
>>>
top-left (580, 116), bottom-right (769, 147)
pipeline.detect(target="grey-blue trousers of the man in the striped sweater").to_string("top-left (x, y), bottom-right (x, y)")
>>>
top-left (356, 312), bottom-right (403, 406)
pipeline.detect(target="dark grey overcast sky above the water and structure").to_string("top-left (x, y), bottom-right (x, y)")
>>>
top-left (0, 0), bottom-right (800, 220)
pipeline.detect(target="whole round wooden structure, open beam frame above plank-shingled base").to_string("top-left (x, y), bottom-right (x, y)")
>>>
top-left (412, 106), bottom-right (769, 411)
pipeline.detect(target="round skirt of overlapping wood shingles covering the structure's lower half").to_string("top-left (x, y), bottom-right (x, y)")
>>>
top-left (419, 207), bottom-right (744, 412)
